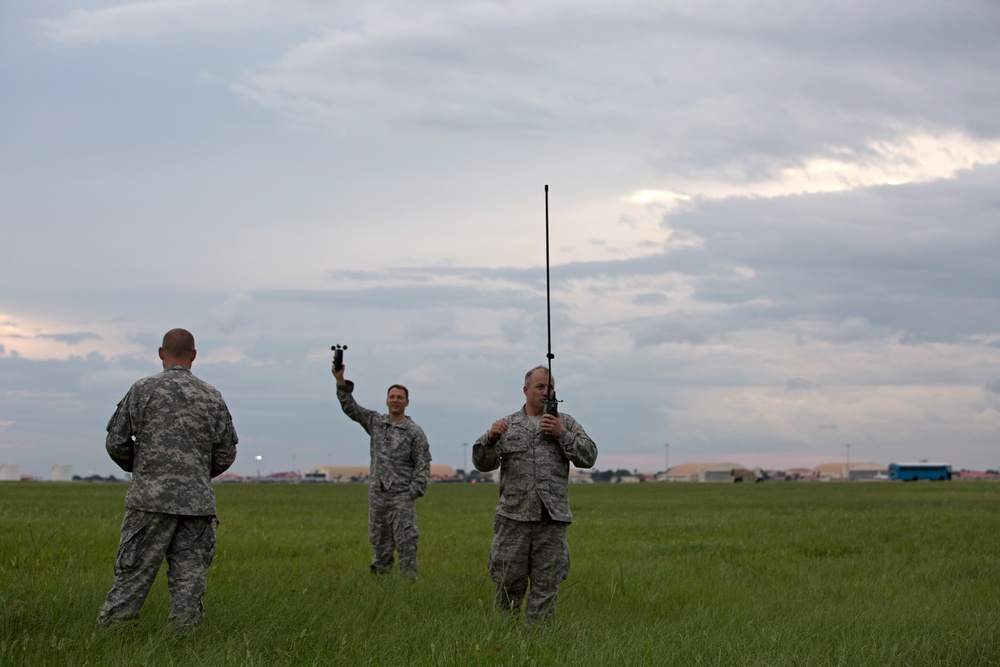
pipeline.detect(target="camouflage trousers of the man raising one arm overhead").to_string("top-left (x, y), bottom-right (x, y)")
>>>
top-left (368, 488), bottom-right (418, 579)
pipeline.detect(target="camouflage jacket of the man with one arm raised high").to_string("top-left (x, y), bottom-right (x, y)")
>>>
top-left (337, 380), bottom-right (431, 498)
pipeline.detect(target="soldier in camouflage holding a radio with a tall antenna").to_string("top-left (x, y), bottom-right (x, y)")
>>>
top-left (472, 366), bottom-right (597, 621)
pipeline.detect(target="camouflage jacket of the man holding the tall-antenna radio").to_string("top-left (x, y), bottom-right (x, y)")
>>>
top-left (472, 408), bottom-right (597, 523)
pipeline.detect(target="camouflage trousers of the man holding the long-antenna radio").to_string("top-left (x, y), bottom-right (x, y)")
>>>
top-left (489, 514), bottom-right (569, 621)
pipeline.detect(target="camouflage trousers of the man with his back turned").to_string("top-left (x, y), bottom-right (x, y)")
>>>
top-left (97, 509), bottom-right (219, 630)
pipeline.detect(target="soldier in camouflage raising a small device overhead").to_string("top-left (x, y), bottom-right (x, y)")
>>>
top-left (332, 364), bottom-right (431, 579)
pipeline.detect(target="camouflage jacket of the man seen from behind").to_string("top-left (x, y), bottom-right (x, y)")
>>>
top-left (105, 366), bottom-right (238, 516)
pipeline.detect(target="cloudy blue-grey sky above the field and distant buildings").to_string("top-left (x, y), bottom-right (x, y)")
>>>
top-left (0, 0), bottom-right (1000, 478)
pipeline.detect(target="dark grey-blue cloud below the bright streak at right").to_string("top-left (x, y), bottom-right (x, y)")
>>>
top-left (645, 167), bottom-right (1000, 341)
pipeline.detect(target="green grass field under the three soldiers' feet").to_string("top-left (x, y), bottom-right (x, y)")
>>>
top-left (0, 482), bottom-right (1000, 667)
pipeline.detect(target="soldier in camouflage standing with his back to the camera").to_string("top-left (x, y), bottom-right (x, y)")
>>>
top-left (97, 329), bottom-right (237, 631)
